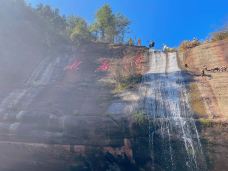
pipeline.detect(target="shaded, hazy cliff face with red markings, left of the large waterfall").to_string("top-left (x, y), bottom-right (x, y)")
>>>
top-left (0, 43), bottom-right (149, 171)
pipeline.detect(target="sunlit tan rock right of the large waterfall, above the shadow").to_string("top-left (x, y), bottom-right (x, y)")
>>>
top-left (179, 39), bottom-right (228, 119)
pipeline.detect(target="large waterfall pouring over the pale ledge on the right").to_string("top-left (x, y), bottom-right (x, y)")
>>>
top-left (141, 52), bottom-right (206, 171)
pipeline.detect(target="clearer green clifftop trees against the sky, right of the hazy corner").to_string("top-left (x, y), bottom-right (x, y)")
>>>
top-left (35, 4), bottom-right (130, 43)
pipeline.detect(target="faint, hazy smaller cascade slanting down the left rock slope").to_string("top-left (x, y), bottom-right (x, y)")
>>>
top-left (0, 57), bottom-right (72, 136)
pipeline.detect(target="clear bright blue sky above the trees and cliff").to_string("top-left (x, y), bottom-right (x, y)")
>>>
top-left (27, 0), bottom-right (228, 47)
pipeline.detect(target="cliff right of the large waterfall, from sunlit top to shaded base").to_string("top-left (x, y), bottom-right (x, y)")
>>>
top-left (179, 39), bottom-right (228, 171)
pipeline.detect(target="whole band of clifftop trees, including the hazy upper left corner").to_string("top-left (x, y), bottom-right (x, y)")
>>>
top-left (0, 0), bottom-right (130, 48)
